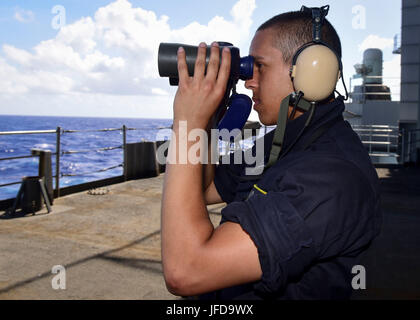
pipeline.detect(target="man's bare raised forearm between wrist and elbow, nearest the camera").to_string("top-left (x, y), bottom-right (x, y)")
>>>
top-left (162, 121), bottom-right (214, 278)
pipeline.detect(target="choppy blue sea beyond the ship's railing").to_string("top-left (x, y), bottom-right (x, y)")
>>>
top-left (0, 115), bottom-right (172, 200)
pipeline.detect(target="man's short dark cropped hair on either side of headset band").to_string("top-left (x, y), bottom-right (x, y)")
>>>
top-left (257, 11), bottom-right (341, 64)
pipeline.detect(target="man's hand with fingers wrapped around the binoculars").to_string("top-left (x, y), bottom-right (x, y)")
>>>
top-left (174, 42), bottom-right (231, 129)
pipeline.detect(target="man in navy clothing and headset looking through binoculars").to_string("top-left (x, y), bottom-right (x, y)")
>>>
top-left (162, 10), bottom-right (381, 299)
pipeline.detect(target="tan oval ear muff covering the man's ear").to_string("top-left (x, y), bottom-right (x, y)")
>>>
top-left (291, 44), bottom-right (340, 102)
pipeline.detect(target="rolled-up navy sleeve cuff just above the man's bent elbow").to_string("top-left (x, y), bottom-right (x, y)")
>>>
top-left (222, 192), bottom-right (316, 293)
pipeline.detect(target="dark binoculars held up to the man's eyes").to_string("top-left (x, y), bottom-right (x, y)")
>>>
top-left (158, 42), bottom-right (254, 86)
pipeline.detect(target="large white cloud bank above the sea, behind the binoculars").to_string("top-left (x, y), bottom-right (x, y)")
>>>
top-left (0, 0), bottom-right (255, 106)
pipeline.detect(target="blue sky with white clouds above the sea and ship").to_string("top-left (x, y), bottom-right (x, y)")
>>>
top-left (0, 0), bottom-right (401, 120)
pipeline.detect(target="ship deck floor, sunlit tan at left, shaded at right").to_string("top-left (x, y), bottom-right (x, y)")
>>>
top-left (0, 167), bottom-right (420, 299)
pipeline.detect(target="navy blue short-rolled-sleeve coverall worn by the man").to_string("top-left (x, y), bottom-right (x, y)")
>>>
top-left (202, 98), bottom-right (382, 299)
